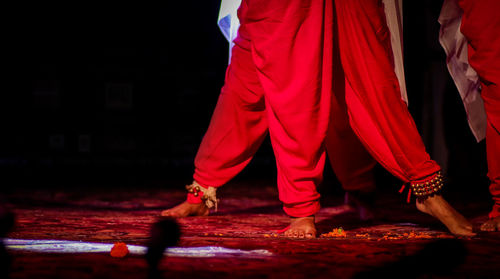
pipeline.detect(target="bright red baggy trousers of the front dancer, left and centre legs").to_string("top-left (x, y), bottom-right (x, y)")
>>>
top-left (194, 0), bottom-right (333, 217)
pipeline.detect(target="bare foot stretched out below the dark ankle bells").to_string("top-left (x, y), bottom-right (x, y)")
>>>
top-left (417, 195), bottom-right (476, 236)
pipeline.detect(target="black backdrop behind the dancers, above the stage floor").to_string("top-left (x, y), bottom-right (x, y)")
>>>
top-left (0, 0), bottom-right (486, 197)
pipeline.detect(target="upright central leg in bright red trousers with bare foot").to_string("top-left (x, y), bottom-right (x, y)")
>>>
top-left (240, 0), bottom-right (333, 237)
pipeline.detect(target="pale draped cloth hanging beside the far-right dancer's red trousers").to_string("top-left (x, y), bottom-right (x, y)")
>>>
top-left (438, 0), bottom-right (486, 141)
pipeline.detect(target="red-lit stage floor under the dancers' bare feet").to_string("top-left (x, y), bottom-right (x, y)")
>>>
top-left (4, 181), bottom-right (500, 279)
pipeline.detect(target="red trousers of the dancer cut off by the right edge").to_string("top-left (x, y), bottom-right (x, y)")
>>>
top-left (459, 0), bottom-right (500, 218)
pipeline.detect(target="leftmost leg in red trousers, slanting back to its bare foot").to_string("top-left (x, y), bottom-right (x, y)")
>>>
top-left (161, 17), bottom-right (267, 217)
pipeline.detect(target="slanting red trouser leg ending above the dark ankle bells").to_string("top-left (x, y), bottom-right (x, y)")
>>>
top-left (335, 0), bottom-right (440, 188)
